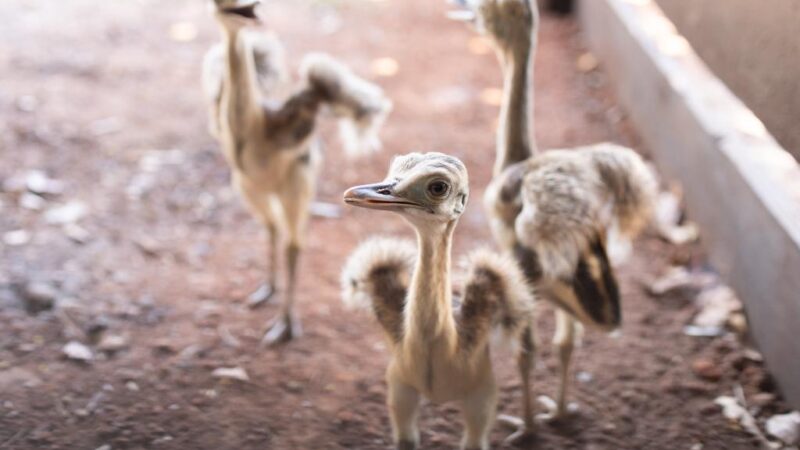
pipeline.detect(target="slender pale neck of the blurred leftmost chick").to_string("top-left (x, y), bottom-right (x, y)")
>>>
top-left (221, 25), bottom-right (261, 129)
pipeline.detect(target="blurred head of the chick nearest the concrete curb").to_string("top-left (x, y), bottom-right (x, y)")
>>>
top-left (448, 0), bottom-right (539, 51)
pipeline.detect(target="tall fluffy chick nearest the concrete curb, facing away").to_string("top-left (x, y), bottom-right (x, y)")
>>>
top-left (451, 0), bottom-right (658, 419)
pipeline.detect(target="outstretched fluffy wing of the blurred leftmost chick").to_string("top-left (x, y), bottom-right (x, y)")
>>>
top-left (300, 53), bottom-right (392, 155)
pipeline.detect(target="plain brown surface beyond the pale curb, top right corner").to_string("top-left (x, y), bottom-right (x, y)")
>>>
top-left (656, 0), bottom-right (800, 160)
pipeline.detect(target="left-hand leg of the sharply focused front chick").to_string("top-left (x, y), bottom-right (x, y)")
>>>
top-left (386, 368), bottom-right (420, 450)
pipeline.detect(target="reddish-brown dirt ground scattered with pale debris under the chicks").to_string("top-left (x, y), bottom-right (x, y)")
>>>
top-left (0, 0), bottom-right (784, 450)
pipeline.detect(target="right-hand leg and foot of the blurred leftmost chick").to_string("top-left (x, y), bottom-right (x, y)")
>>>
top-left (261, 150), bottom-right (316, 345)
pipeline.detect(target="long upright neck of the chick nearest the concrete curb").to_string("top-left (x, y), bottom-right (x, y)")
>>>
top-left (494, 43), bottom-right (535, 176)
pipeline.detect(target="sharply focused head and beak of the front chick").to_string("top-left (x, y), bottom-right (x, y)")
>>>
top-left (344, 153), bottom-right (469, 226)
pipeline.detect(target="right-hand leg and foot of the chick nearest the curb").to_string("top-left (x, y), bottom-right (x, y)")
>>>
top-left (537, 309), bottom-right (578, 421)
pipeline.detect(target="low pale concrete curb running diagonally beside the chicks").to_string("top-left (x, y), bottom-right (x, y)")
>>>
top-left (579, 0), bottom-right (800, 408)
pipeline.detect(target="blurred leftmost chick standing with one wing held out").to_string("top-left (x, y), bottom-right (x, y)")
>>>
top-left (203, 0), bottom-right (391, 344)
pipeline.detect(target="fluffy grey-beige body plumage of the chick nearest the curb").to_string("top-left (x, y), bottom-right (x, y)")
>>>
top-left (485, 144), bottom-right (657, 328)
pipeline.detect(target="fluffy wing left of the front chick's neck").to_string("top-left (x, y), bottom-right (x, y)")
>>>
top-left (341, 237), bottom-right (417, 342)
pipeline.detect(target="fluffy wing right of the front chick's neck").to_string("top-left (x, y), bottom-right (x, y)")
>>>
top-left (458, 250), bottom-right (534, 353)
